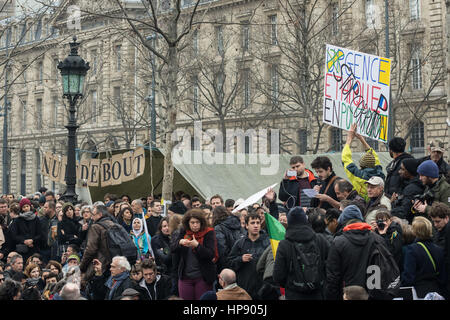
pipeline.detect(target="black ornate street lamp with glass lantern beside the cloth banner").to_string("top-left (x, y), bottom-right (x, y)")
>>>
top-left (58, 37), bottom-right (90, 204)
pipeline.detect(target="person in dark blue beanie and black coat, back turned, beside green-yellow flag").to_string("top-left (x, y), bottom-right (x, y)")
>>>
top-left (273, 207), bottom-right (330, 300)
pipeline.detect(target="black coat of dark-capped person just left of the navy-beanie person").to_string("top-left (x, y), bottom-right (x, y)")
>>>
top-left (391, 177), bottom-right (425, 223)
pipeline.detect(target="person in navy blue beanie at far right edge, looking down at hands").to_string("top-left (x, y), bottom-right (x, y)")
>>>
top-left (413, 160), bottom-right (450, 215)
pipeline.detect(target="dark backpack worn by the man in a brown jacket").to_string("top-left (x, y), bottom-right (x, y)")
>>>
top-left (97, 221), bottom-right (137, 265)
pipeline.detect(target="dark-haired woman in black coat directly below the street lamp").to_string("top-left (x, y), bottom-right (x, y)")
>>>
top-left (57, 202), bottom-right (82, 257)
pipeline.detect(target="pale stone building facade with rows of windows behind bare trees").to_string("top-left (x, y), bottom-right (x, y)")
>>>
top-left (0, 0), bottom-right (450, 194)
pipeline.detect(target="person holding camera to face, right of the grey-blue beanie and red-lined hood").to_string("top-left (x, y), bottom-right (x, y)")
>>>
top-left (371, 210), bottom-right (403, 266)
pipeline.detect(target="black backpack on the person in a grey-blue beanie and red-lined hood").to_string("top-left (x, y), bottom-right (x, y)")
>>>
top-left (362, 234), bottom-right (400, 300)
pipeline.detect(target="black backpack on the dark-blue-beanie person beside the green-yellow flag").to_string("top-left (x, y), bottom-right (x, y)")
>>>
top-left (286, 238), bottom-right (324, 293)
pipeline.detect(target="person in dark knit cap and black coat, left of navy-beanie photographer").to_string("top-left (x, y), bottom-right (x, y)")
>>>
top-left (391, 159), bottom-right (425, 223)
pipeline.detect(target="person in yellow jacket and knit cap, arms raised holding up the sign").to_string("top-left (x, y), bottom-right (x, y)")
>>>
top-left (342, 123), bottom-right (385, 201)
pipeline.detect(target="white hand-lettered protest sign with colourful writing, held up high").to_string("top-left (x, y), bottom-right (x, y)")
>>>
top-left (323, 44), bottom-right (391, 142)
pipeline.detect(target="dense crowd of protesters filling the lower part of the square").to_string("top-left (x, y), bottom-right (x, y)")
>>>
top-left (0, 127), bottom-right (450, 300)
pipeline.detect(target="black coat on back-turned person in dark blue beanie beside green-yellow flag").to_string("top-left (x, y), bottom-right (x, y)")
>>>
top-left (273, 225), bottom-right (330, 300)
